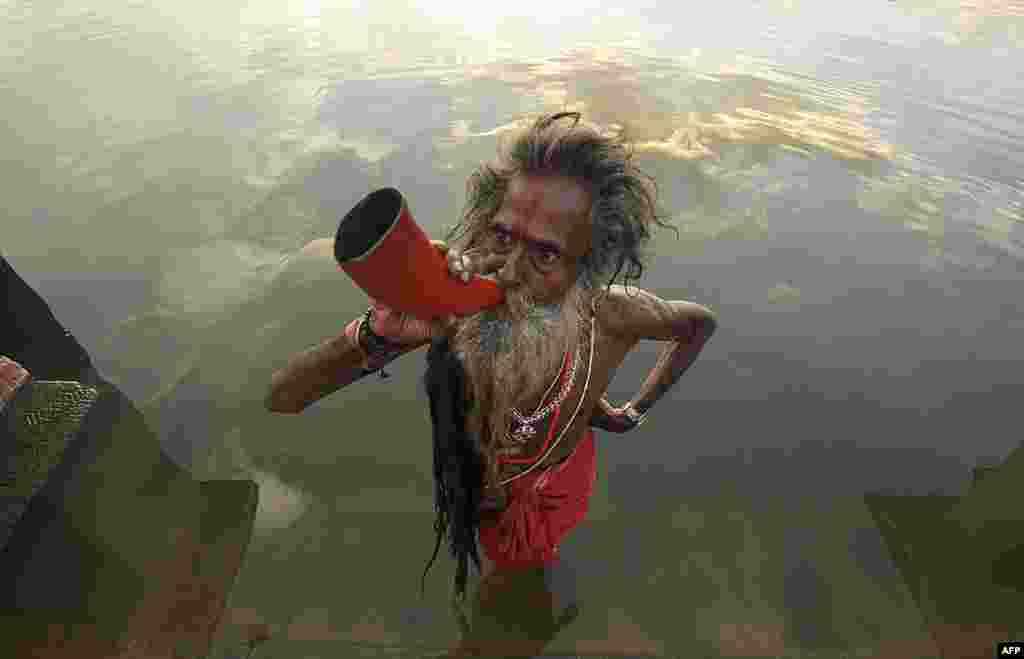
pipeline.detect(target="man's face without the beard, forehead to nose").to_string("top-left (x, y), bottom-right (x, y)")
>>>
top-left (479, 169), bottom-right (591, 305)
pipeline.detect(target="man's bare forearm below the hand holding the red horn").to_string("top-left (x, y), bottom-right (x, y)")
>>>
top-left (264, 323), bottom-right (430, 414)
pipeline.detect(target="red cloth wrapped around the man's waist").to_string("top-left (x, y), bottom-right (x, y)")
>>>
top-left (479, 429), bottom-right (597, 568)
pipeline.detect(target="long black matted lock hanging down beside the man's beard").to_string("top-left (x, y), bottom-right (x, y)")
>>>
top-left (420, 338), bottom-right (483, 603)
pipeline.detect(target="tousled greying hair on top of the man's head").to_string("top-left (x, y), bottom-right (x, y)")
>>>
top-left (446, 113), bottom-right (678, 298)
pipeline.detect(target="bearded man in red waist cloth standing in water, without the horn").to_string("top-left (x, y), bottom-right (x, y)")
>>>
top-left (266, 113), bottom-right (716, 656)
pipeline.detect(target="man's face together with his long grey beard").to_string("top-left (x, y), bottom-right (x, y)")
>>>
top-left (453, 176), bottom-right (590, 475)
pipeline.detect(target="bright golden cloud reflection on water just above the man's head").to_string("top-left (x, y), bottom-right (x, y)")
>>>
top-left (452, 49), bottom-right (894, 164)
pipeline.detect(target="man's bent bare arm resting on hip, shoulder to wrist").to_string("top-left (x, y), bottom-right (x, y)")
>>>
top-left (596, 285), bottom-right (718, 414)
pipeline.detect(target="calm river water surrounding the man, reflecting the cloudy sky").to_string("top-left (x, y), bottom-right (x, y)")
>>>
top-left (0, 0), bottom-right (1024, 656)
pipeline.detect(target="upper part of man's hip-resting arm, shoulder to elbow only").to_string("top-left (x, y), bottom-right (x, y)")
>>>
top-left (594, 285), bottom-right (716, 342)
